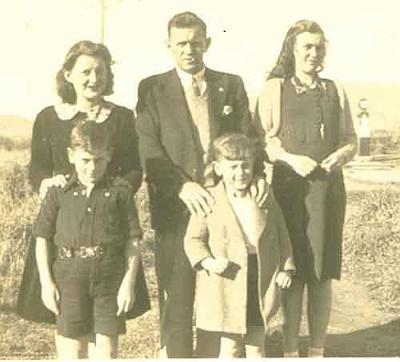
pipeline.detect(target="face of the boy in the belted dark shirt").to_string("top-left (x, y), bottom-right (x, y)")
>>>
top-left (68, 148), bottom-right (110, 186)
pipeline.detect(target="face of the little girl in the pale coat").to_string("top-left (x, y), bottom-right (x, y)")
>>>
top-left (214, 157), bottom-right (254, 191)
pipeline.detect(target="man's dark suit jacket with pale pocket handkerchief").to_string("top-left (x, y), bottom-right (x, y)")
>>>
top-left (137, 69), bottom-right (255, 230)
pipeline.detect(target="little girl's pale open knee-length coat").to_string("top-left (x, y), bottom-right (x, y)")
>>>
top-left (184, 182), bottom-right (295, 334)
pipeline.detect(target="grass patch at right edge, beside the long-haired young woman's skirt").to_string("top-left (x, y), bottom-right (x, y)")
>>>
top-left (344, 188), bottom-right (400, 310)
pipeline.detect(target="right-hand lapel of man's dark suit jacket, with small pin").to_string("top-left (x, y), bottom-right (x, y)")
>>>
top-left (205, 68), bottom-right (228, 140)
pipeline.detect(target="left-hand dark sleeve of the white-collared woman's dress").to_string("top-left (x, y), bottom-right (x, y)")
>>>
top-left (29, 111), bottom-right (54, 191)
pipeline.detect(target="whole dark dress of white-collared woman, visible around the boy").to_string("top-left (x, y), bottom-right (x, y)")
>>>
top-left (17, 106), bottom-right (150, 323)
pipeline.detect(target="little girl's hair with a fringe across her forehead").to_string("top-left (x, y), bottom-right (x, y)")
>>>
top-left (204, 133), bottom-right (258, 187)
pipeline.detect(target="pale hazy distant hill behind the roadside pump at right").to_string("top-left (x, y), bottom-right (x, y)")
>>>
top-left (249, 82), bottom-right (400, 130)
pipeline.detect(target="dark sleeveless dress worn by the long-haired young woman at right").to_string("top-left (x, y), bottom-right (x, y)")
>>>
top-left (272, 79), bottom-right (346, 281)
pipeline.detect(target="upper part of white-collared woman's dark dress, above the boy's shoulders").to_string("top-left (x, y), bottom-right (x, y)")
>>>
top-left (29, 106), bottom-right (141, 192)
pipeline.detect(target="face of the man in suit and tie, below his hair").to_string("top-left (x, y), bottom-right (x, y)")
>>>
top-left (168, 26), bottom-right (211, 74)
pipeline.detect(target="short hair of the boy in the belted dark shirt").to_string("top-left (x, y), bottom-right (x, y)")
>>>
top-left (69, 121), bottom-right (110, 152)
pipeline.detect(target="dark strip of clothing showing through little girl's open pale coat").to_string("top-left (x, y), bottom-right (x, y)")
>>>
top-left (246, 254), bottom-right (264, 326)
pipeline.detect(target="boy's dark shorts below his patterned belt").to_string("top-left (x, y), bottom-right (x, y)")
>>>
top-left (53, 256), bottom-right (126, 338)
